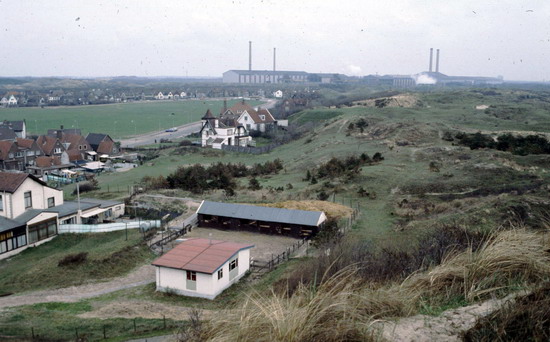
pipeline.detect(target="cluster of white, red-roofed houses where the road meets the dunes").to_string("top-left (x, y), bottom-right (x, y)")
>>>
top-left (199, 100), bottom-right (277, 149)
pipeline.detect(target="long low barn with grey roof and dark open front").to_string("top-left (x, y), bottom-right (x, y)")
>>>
top-left (197, 201), bottom-right (327, 238)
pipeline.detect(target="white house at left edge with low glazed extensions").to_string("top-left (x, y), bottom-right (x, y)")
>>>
top-left (0, 171), bottom-right (125, 259)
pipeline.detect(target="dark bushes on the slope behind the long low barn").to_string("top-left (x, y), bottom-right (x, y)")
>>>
top-left (141, 159), bottom-right (283, 196)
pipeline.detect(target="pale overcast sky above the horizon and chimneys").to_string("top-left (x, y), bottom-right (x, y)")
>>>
top-left (0, 0), bottom-right (550, 81)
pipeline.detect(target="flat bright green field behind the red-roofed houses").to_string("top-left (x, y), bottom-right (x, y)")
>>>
top-left (0, 100), bottom-right (261, 139)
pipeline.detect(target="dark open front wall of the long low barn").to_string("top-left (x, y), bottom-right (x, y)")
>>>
top-left (198, 214), bottom-right (319, 238)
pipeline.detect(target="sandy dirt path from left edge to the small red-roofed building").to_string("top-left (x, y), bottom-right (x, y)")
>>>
top-left (0, 265), bottom-right (155, 309)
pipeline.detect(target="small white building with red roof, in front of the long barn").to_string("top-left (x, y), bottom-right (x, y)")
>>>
top-left (152, 238), bottom-right (254, 299)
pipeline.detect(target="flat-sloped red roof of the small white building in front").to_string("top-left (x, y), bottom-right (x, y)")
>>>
top-left (152, 238), bottom-right (254, 274)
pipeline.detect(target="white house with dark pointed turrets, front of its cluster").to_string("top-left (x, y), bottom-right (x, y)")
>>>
top-left (200, 109), bottom-right (252, 149)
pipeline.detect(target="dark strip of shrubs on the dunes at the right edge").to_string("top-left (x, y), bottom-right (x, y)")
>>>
top-left (443, 132), bottom-right (550, 156)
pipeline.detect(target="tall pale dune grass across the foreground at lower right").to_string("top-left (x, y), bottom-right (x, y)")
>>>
top-left (196, 229), bottom-right (550, 341)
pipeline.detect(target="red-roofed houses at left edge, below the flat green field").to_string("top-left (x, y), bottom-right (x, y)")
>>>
top-left (0, 120), bottom-right (120, 177)
